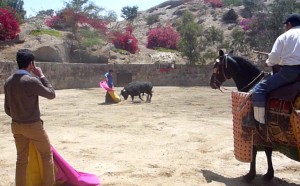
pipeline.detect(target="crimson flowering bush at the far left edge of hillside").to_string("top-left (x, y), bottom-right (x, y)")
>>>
top-left (0, 8), bottom-right (20, 41)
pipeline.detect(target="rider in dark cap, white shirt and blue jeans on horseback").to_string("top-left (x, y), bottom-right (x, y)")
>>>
top-left (252, 14), bottom-right (300, 126)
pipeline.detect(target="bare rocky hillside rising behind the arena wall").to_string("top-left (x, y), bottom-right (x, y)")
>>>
top-left (0, 0), bottom-right (260, 64)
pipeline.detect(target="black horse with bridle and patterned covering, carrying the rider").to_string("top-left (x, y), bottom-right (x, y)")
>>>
top-left (210, 50), bottom-right (300, 182)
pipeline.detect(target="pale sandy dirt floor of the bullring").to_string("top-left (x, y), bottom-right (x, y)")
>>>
top-left (0, 87), bottom-right (300, 186)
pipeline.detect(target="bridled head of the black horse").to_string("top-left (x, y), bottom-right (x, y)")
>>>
top-left (210, 50), bottom-right (231, 89)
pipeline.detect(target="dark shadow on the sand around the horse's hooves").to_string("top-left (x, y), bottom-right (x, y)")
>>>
top-left (201, 170), bottom-right (300, 186)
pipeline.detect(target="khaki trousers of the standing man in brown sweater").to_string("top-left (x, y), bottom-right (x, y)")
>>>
top-left (11, 121), bottom-right (55, 186)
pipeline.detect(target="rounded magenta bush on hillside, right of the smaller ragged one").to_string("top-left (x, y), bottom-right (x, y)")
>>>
top-left (147, 26), bottom-right (180, 50)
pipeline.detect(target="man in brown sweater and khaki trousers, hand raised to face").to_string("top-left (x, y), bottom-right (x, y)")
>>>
top-left (4, 49), bottom-right (55, 186)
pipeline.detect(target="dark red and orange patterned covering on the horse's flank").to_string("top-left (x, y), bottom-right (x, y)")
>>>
top-left (266, 80), bottom-right (300, 161)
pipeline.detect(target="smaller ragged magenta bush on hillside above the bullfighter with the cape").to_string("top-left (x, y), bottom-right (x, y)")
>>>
top-left (112, 32), bottom-right (139, 54)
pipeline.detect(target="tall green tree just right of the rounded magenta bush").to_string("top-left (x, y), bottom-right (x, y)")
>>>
top-left (177, 12), bottom-right (202, 65)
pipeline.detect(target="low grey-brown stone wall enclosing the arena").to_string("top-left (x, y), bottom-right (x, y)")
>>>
top-left (0, 62), bottom-right (230, 93)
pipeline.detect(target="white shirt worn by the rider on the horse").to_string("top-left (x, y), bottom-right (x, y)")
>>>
top-left (266, 26), bottom-right (300, 66)
